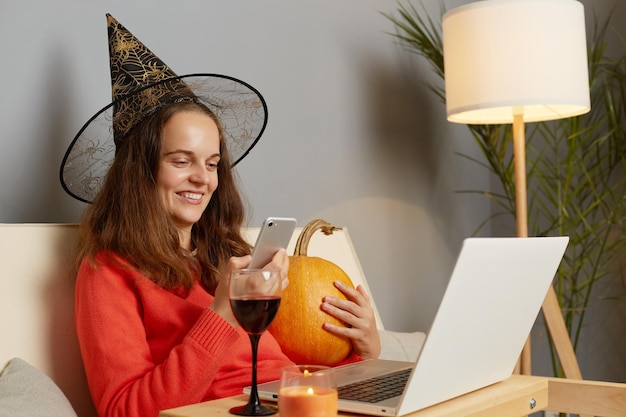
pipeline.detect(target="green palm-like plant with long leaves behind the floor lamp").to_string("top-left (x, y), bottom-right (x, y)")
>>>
top-left (383, 3), bottom-right (626, 376)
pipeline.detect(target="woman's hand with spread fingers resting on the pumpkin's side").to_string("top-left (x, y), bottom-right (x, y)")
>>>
top-left (322, 281), bottom-right (381, 359)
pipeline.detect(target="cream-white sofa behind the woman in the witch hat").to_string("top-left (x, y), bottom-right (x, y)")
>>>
top-left (0, 224), bottom-right (424, 417)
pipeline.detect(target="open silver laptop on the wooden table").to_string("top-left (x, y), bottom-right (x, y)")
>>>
top-left (251, 237), bottom-right (569, 416)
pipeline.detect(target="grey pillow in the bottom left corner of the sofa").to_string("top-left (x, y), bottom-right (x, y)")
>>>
top-left (0, 358), bottom-right (77, 417)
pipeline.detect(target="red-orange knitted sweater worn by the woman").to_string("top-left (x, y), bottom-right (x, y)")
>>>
top-left (75, 250), bottom-right (292, 417)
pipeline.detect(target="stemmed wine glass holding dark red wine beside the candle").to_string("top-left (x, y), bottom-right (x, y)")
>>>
top-left (229, 269), bottom-right (282, 416)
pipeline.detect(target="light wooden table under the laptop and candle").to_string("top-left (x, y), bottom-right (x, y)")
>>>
top-left (159, 375), bottom-right (626, 417)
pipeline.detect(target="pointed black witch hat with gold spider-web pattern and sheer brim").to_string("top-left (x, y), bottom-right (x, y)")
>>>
top-left (60, 14), bottom-right (267, 202)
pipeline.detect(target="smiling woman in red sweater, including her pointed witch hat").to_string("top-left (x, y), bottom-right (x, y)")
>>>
top-left (62, 16), bottom-right (298, 416)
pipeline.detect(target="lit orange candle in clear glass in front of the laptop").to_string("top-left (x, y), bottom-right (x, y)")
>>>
top-left (278, 386), bottom-right (337, 417)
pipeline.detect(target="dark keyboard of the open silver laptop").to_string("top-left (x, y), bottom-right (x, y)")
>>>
top-left (337, 368), bottom-right (412, 403)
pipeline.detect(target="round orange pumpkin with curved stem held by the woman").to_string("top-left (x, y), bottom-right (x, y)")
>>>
top-left (269, 220), bottom-right (354, 365)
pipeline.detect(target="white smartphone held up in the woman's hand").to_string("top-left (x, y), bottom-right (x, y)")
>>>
top-left (248, 217), bottom-right (296, 269)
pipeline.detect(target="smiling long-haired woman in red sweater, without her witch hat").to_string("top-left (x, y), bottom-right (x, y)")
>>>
top-left (63, 13), bottom-right (380, 417)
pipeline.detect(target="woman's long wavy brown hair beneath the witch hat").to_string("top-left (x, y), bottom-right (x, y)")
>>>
top-left (77, 102), bottom-right (251, 294)
